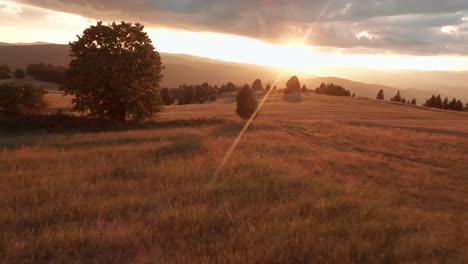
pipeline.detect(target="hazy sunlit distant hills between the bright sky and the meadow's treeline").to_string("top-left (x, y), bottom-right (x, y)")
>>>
top-left (0, 43), bottom-right (468, 103)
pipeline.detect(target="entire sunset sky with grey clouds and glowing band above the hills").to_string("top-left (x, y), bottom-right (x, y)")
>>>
top-left (0, 0), bottom-right (468, 74)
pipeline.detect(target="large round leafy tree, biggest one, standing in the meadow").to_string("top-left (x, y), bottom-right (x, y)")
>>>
top-left (63, 22), bottom-right (163, 121)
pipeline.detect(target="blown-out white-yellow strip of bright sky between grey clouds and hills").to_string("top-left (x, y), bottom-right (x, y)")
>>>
top-left (0, 0), bottom-right (468, 74)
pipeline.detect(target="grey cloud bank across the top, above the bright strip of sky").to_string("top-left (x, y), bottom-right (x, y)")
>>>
top-left (10, 0), bottom-right (468, 54)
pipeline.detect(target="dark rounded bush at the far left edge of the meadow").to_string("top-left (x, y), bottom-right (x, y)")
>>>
top-left (0, 83), bottom-right (47, 116)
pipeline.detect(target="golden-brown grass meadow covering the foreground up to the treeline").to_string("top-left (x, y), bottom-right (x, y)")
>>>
top-left (0, 91), bottom-right (468, 263)
